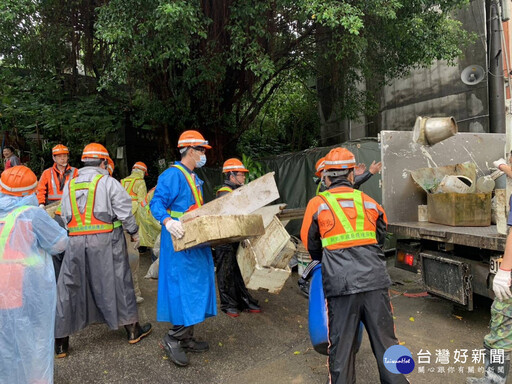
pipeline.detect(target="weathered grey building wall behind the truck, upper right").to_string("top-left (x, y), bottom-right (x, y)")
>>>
top-left (375, 0), bottom-right (489, 132)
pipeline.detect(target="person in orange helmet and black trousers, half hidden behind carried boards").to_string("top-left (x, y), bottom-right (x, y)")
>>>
top-left (215, 158), bottom-right (261, 317)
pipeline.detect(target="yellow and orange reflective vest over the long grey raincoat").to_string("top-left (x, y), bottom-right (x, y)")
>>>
top-left (68, 174), bottom-right (114, 236)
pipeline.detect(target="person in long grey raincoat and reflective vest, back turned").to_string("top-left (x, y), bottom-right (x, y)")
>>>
top-left (55, 143), bottom-right (151, 357)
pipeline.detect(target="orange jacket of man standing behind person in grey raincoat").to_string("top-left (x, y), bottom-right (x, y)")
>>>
top-left (37, 164), bottom-right (78, 204)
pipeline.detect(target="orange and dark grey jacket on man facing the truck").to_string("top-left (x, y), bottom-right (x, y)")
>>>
top-left (301, 181), bottom-right (391, 298)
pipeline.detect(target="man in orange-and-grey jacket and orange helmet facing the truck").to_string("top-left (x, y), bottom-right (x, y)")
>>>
top-left (301, 148), bottom-right (408, 384)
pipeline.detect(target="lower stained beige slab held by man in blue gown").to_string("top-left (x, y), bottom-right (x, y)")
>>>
top-left (172, 215), bottom-right (265, 252)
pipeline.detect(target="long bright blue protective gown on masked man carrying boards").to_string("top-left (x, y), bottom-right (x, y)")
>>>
top-left (150, 162), bottom-right (217, 326)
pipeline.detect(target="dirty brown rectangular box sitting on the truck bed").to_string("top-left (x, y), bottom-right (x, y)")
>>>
top-left (427, 193), bottom-right (491, 227)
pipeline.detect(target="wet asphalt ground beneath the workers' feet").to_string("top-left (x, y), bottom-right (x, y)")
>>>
top-left (55, 257), bottom-right (491, 384)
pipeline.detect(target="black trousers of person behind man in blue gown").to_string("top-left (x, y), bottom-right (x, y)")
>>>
top-left (215, 243), bottom-right (258, 311)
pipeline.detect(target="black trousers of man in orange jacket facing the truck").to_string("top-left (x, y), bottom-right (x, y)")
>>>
top-left (327, 288), bottom-right (409, 384)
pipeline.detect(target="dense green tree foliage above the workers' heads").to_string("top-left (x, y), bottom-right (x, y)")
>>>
top-left (0, 0), bottom-right (469, 162)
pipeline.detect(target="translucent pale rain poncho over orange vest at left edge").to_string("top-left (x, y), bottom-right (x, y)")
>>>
top-left (0, 193), bottom-right (68, 384)
